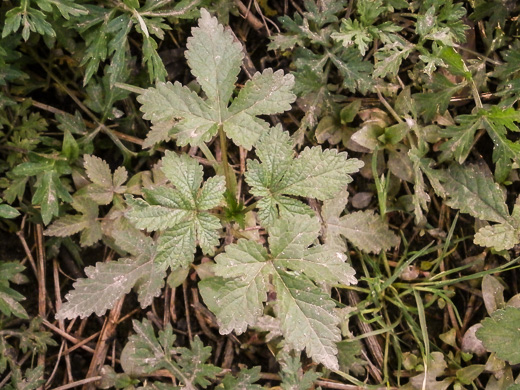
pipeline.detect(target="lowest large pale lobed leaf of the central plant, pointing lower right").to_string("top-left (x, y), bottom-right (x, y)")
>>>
top-left (199, 215), bottom-right (357, 369)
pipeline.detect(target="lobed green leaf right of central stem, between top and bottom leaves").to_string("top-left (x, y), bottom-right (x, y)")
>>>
top-left (245, 127), bottom-right (363, 227)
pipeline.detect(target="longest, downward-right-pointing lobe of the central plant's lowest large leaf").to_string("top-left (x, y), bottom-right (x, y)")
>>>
top-left (273, 271), bottom-right (341, 370)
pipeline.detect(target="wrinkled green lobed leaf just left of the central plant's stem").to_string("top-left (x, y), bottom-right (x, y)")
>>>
top-left (125, 151), bottom-right (225, 269)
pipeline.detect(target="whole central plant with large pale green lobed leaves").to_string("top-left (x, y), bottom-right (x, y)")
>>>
top-left (50, 10), bottom-right (374, 369)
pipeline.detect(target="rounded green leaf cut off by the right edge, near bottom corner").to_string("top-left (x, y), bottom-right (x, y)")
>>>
top-left (477, 307), bottom-right (520, 364)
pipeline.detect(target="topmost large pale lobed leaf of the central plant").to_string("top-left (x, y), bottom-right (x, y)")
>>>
top-left (137, 8), bottom-right (296, 150)
